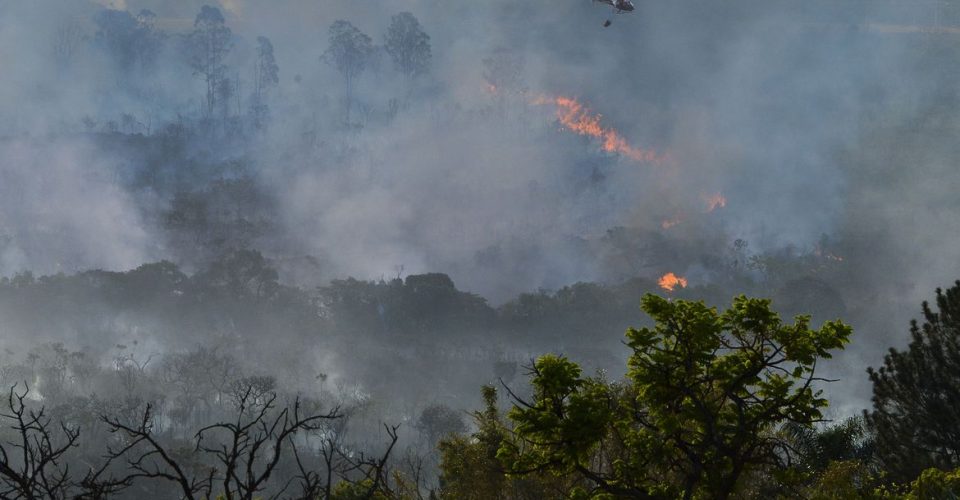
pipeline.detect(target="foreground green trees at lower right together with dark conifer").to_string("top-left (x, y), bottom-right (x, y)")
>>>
top-left (439, 281), bottom-right (960, 500)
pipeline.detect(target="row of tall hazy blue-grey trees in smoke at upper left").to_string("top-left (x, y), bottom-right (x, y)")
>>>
top-left (50, 5), bottom-right (432, 136)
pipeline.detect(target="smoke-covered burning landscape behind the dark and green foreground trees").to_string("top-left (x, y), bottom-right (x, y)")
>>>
top-left (0, 0), bottom-right (960, 498)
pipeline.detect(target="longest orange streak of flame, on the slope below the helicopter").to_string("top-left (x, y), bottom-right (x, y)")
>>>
top-left (533, 96), bottom-right (666, 164)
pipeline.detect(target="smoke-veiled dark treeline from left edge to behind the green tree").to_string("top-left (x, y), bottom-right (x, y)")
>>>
top-left (0, 250), bottom-right (668, 393)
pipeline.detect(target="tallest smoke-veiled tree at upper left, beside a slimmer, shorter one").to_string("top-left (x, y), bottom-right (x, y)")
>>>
top-left (187, 5), bottom-right (233, 117)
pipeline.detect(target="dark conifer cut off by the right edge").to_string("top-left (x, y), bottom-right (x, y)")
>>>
top-left (864, 281), bottom-right (960, 481)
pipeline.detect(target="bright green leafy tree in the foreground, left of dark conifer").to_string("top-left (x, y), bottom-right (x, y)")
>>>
top-left (498, 294), bottom-right (851, 498)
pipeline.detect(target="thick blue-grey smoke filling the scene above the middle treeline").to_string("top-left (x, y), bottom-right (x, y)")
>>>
top-left (0, 0), bottom-right (960, 414)
